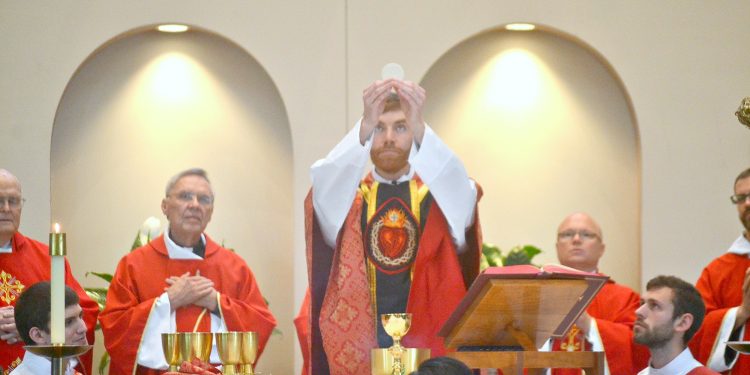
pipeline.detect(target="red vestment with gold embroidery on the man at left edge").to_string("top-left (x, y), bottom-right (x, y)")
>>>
top-left (0, 232), bottom-right (99, 375)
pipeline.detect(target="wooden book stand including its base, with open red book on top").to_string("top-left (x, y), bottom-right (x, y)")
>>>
top-left (439, 266), bottom-right (608, 375)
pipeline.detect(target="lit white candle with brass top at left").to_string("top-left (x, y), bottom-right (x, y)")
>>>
top-left (49, 223), bottom-right (65, 345)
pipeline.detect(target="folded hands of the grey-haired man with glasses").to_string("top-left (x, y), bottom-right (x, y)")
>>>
top-left (164, 271), bottom-right (218, 312)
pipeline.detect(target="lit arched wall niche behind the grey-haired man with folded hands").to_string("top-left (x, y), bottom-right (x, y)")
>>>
top-left (51, 26), bottom-right (294, 373)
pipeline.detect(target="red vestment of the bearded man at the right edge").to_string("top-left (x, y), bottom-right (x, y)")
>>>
top-left (690, 253), bottom-right (750, 374)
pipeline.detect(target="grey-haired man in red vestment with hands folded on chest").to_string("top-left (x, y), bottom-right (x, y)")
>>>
top-left (100, 169), bottom-right (276, 375)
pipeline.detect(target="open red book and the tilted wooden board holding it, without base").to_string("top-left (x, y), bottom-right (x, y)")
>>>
top-left (438, 264), bottom-right (608, 350)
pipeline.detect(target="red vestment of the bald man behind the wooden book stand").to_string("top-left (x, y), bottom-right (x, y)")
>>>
top-left (552, 280), bottom-right (649, 375)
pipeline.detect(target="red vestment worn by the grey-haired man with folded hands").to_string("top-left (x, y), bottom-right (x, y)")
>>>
top-left (99, 236), bottom-right (276, 375)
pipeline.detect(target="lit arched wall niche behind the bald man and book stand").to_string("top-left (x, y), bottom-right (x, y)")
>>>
top-left (422, 26), bottom-right (641, 290)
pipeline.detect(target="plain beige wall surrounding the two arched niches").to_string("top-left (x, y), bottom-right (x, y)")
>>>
top-left (0, 0), bottom-right (750, 373)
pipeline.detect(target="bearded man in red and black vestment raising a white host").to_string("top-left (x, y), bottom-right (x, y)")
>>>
top-left (296, 79), bottom-right (481, 375)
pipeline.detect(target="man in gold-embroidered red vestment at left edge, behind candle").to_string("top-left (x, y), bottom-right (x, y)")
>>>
top-left (0, 169), bottom-right (99, 375)
